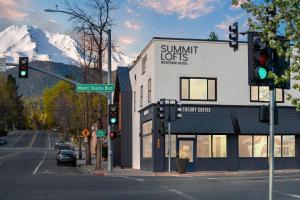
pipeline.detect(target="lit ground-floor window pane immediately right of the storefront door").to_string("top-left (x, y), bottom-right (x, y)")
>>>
top-left (197, 135), bottom-right (211, 158)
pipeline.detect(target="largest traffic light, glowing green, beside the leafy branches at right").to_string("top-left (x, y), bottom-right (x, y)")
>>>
top-left (248, 32), bottom-right (273, 86)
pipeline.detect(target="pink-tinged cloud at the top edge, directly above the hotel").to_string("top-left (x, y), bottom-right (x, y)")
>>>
top-left (135, 0), bottom-right (220, 19)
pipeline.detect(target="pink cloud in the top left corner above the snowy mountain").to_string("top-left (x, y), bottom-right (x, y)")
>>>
top-left (0, 0), bottom-right (29, 21)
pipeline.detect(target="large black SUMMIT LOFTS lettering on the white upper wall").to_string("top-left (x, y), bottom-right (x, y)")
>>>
top-left (160, 44), bottom-right (198, 65)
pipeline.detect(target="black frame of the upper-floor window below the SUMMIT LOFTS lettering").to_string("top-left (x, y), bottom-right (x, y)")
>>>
top-left (179, 77), bottom-right (218, 101)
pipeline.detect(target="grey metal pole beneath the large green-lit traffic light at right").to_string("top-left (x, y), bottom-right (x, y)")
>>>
top-left (269, 86), bottom-right (276, 200)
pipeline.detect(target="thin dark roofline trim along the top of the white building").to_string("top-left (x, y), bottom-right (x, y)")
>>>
top-left (129, 37), bottom-right (248, 71)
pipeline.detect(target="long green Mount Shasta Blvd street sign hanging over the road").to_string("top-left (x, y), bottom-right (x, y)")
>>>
top-left (76, 84), bottom-right (115, 92)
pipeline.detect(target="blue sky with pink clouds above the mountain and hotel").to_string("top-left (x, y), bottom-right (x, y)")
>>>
top-left (0, 0), bottom-right (248, 58)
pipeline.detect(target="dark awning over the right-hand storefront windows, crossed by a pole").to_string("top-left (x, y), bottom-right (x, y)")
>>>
top-left (237, 114), bottom-right (300, 134)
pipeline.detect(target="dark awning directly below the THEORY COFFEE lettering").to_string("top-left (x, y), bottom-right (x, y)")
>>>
top-left (171, 113), bottom-right (234, 134)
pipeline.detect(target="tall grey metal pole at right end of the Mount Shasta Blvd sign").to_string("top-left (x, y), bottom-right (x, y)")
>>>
top-left (107, 29), bottom-right (112, 172)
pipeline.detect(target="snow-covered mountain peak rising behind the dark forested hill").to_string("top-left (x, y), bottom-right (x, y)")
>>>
top-left (0, 25), bottom-right (132, 70)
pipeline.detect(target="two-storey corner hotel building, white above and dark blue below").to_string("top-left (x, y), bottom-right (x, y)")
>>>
top-left (114, 38), bottom-right (300, 171)
